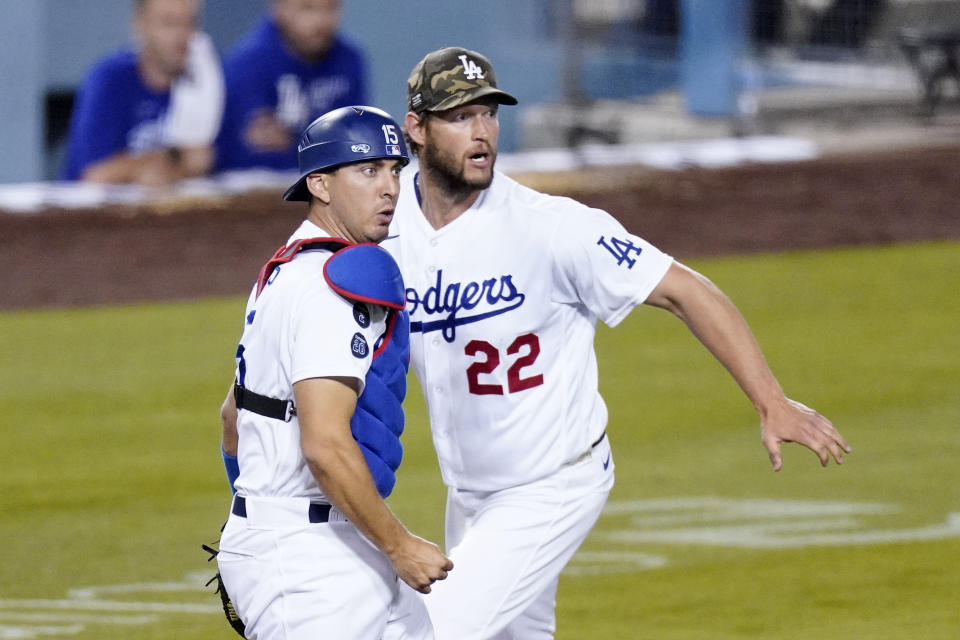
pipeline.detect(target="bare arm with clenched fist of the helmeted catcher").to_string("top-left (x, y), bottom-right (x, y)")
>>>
top-left (293, 378), bottom-right (453, 593)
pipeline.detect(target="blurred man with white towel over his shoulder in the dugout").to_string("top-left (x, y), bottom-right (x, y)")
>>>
top-left (60, 0), bottom-right (224, 186)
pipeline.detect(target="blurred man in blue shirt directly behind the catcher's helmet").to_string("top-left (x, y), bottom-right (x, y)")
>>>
top-left (217, 0), bottom-right (367, 170)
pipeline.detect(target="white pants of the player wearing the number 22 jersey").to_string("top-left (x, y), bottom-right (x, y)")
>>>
top-left (423, 438), bottom-right (614, 640)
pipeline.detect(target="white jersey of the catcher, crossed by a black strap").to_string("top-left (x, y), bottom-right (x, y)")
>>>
top-left (235, 221), bottom-right (386, 501)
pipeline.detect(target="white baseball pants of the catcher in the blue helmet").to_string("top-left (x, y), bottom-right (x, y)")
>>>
top-left (217, 498), bottom-right (434, 640)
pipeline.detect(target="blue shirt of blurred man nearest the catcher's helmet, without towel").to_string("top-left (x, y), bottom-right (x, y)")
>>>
top-left (217, 18), bottom-right (366, 170)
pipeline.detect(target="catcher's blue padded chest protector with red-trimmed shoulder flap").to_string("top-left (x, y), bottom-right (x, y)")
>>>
top-left (324, 244), bottom-right (410, 498)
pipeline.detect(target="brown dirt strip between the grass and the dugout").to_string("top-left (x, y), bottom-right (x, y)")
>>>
top-left (0, 147), bottom-right (960, 310)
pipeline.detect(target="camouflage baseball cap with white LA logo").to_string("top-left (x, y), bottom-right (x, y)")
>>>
top-left (407, 47), bottom-right (517, 113)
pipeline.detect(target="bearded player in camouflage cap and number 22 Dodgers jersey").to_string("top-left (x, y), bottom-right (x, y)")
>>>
top-left (384, 47), bottom-right (849, 640)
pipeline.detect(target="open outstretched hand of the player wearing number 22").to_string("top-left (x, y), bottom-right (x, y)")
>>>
top-left (760, 398), bottom-right (852, 471)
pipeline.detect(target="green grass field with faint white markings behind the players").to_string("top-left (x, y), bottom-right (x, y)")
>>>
top-left (0, 242), bottom-right (960, 640)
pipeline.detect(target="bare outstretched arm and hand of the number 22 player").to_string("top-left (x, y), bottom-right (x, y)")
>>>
top-left (646, 262), bottom-right (851, 471)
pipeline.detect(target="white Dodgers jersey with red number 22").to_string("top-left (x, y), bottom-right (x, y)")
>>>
top-left (386, 172), bottom-right (673, 491)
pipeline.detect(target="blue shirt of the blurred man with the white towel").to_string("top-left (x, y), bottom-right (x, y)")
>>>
top-left (60, 49), bottom-right (170, 180)
